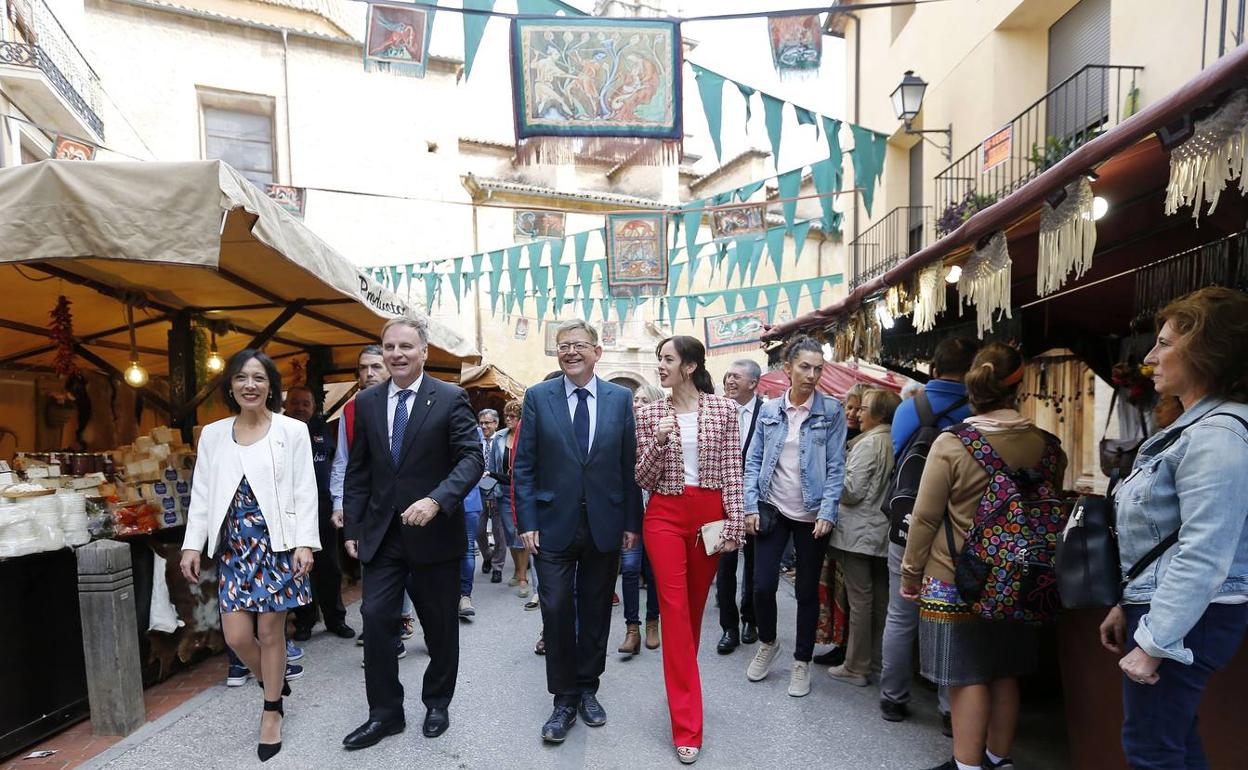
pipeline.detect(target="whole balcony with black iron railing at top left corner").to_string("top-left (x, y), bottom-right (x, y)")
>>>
top-left (0, 0), bottom-right (104, 141)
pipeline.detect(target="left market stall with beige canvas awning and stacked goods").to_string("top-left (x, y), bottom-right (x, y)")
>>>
top-left (0, 161), bottom-right (477, 756)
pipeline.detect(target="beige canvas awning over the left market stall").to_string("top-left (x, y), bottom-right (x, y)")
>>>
top-left (0, 161), bottom-right (479, 394)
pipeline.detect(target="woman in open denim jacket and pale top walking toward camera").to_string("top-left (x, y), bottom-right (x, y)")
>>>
top-left (745, 337), bottom-right (845, 698)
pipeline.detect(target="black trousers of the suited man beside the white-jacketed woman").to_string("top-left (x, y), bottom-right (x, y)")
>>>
top-left (361, 517), bottom-right (463, 721)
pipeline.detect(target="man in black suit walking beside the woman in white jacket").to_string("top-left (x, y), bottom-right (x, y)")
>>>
top-left (342, 318), bottom-right (485, 749)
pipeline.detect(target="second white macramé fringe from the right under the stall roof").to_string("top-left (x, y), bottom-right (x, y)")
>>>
top-left (1036, 176), bottom-right (1096, 297)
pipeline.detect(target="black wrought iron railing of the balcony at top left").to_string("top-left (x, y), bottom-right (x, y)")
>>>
top-left (0, 0), bottom-right (104, 139)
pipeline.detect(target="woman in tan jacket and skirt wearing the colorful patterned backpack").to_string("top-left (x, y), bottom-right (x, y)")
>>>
top-left (901, 342), bottom-right (1066, 770)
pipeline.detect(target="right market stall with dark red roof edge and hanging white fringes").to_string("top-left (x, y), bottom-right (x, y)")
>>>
top-left (764, 46), bottom-right (1248, 768)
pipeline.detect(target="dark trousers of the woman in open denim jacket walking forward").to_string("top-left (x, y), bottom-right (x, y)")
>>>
top-left (754, 514), bottom-right (831, 663)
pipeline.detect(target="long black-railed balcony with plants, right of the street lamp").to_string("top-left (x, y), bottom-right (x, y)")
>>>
top-left (936, 64), bottom-right (1143, 230)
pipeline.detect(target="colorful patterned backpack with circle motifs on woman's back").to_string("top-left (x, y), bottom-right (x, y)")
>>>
top-left (945, 423), bottom-right (1071, 623)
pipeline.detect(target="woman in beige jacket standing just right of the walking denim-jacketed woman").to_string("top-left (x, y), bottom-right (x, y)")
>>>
top-left (827, 388), bottom-right (901, 688)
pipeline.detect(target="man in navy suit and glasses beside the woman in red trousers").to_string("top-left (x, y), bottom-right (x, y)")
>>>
top-left (512, 319), bottom-right (641, 743)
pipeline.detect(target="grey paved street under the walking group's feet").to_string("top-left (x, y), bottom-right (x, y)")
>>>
top-left (87, 559), bottom-right (1065, 770)
